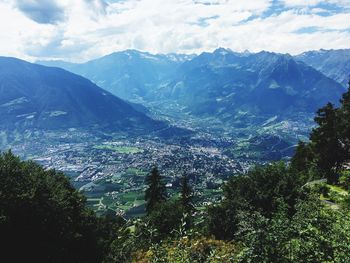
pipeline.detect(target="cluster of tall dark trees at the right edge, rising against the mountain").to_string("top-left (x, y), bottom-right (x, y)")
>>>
top-left (291, 79), bottom-right (350, 184)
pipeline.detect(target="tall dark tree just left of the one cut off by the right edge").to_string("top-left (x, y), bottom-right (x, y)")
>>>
top-left (310, 103), bottom-right (345, 183)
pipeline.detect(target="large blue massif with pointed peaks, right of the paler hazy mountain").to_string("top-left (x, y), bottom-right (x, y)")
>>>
top-left (161, 48), bottom-right (345, 120)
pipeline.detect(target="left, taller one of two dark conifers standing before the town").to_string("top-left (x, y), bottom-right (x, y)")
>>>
top-left (145, 167), bottom-right (167, 214)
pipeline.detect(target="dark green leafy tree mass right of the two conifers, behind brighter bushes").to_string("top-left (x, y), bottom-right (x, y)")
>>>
top-left (208, 163), bottom-right (304, 239)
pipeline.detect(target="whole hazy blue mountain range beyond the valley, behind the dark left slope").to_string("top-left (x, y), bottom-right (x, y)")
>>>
top-left (38, 48), bottom-right (349, 131)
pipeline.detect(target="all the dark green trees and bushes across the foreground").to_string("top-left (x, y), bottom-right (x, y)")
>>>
top-left (0, 81), bottom-right (350, 263)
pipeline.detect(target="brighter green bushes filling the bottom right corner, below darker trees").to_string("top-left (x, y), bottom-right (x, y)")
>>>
top-left (239, 195), bottom-right (350, 262)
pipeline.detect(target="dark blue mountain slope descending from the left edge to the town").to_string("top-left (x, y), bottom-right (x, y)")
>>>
top-left (0, 57), bottom-right (168, 133)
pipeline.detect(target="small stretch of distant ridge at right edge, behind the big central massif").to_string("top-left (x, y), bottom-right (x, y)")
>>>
top-left (295, 49), bottom-right (350, 87)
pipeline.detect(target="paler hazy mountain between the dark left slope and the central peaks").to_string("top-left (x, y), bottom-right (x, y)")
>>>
top-left (37, 50), bottom-right (193, 101)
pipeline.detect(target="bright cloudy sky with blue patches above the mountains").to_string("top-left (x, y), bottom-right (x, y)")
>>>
top-left (0, 0), bottom-right (350, 62)
